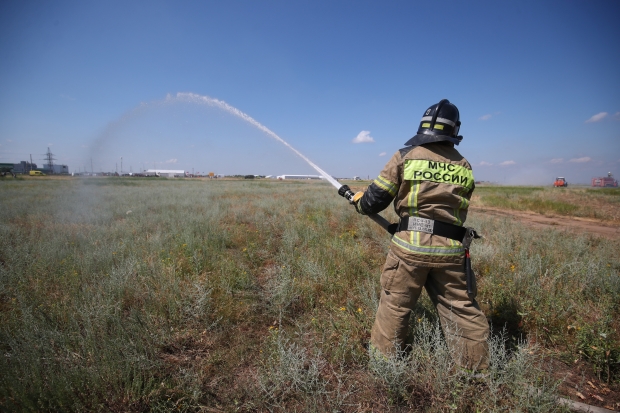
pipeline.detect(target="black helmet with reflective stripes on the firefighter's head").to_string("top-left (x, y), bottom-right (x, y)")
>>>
top-left (405, 99), bottom-right (463, 146)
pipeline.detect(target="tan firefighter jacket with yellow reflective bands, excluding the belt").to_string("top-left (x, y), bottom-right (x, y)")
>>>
top-left (359, 142), bottom-right (475, 263)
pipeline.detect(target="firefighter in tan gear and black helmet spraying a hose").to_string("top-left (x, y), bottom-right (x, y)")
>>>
top-left (344, 99), bottom-right (489, 370)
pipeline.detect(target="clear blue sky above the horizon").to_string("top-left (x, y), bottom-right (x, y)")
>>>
top-left (0, 0), bottom-right (620, 184)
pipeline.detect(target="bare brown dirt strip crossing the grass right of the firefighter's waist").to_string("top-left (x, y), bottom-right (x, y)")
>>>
top-left (469, 206), bottom-right (620, 239)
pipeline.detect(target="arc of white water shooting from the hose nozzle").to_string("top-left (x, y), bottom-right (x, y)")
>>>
top-left (166, 92), bottom-right (390, 231)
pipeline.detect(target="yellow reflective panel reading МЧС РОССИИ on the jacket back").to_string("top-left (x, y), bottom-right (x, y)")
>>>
top-left (404, 159), bottom-right (474, 189)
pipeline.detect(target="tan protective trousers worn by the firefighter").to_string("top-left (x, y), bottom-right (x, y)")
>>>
top-left (370, 246), bottom-right (489, 370)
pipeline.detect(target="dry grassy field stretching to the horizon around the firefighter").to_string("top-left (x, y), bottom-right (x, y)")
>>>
top-left (0, 178), bottom-right (620, 412)
